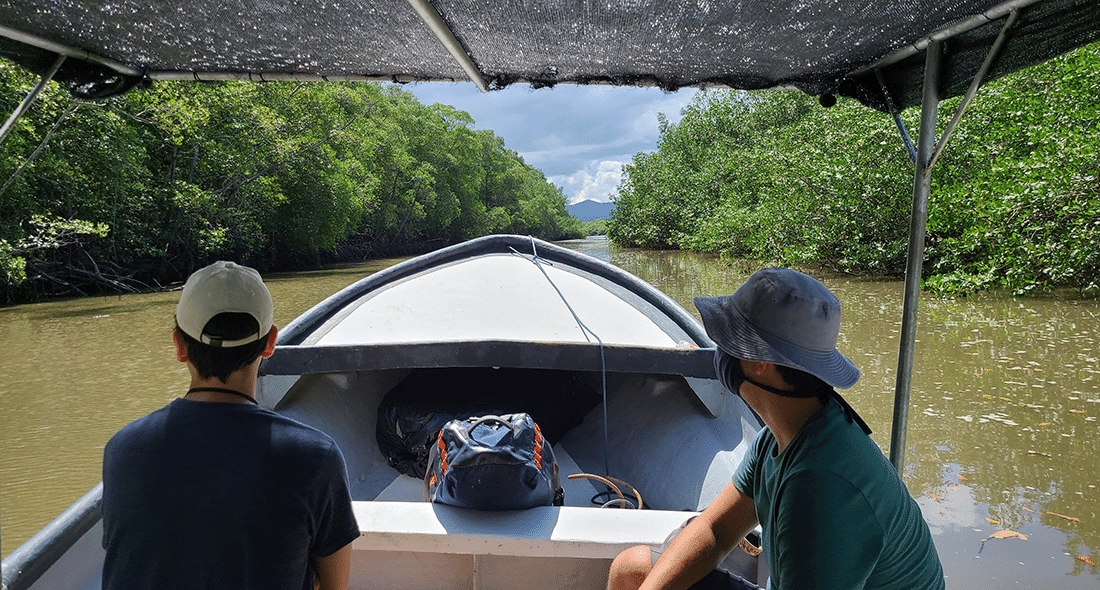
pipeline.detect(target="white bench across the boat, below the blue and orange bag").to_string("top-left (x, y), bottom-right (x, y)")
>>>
top-left (351, 501), bottom-right (769, 590)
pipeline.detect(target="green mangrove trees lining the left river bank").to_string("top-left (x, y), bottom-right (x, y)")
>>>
top-left (0, 70), bottom-right (582, 304)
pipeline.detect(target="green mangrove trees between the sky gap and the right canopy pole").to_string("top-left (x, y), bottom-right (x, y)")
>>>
top-left (608, 91), bottom-right (912, 270)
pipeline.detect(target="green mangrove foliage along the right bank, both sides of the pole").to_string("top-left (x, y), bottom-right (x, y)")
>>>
top-left (607, 44), bottom-right (1100, 294)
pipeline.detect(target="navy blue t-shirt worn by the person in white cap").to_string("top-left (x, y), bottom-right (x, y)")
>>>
top-left (103, 398), bottom-right (359, 590)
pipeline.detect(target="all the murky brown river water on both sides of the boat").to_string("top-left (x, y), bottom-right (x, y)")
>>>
top-left (0, 239), bottom-right (1100, 590)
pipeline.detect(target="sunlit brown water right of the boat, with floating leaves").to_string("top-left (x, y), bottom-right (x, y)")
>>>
top-left (563, 238), bottom-right (1100, 590)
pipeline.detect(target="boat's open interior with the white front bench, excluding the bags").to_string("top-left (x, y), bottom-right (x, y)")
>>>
top-left (261, 361), bottom-right (767, 588)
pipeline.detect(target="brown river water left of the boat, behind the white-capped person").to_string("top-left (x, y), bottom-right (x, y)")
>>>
top-left (0, 259), bottom-right (402, 556)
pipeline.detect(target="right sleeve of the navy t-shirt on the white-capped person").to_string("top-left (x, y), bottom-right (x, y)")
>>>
top-left (310, 445), bottom-right (359, 557)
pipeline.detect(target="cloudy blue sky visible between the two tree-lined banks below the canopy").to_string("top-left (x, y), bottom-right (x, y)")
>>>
top-left (402, 83), bottom-right (696, 203)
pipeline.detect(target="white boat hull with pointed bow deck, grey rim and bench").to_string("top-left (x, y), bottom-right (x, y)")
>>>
top-left (4, 236), bottom-right (763, 590)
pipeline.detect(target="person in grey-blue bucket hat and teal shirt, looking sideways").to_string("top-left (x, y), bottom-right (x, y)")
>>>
top-left (608, 269), bottom-right (944, 590)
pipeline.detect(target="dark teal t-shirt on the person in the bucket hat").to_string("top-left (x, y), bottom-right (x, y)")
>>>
top-left (734, 398), bottom-right (944, 590)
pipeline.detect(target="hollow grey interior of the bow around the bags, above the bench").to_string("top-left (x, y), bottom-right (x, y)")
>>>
top-left (271, 368), bottom-right (758, 511)
